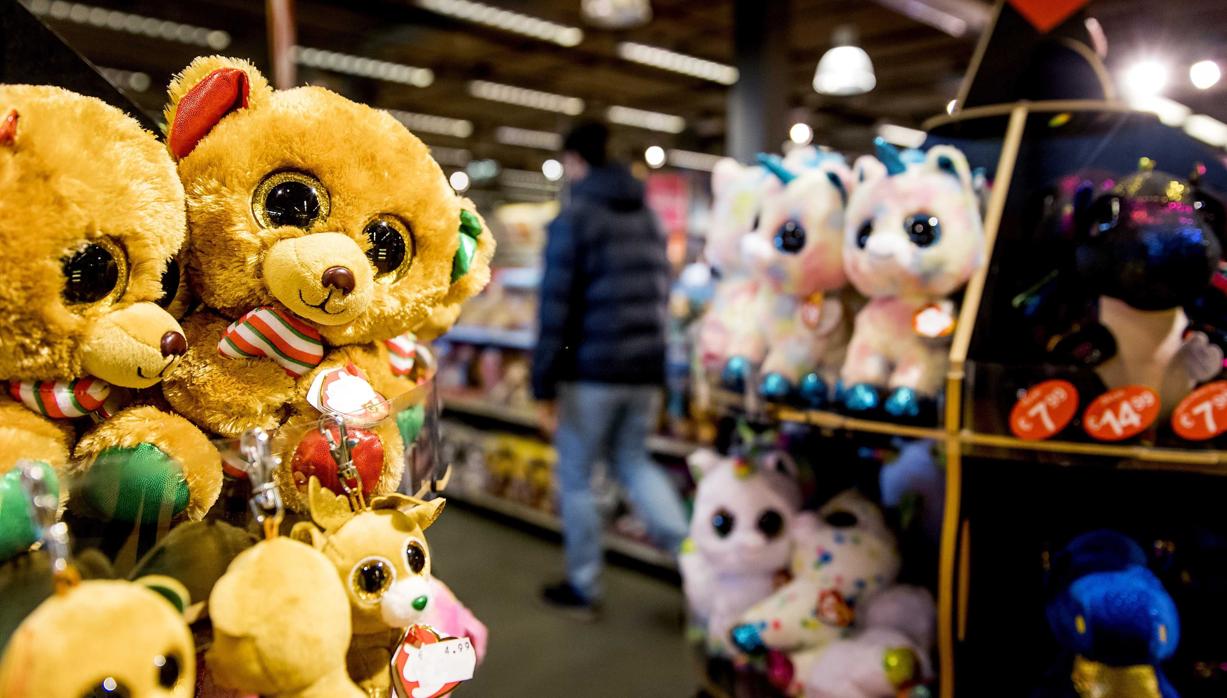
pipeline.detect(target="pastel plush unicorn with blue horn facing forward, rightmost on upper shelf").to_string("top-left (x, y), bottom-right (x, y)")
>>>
top-left (842, 139), bottom-right (984, 420)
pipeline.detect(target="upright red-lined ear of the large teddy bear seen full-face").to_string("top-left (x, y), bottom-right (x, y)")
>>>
top-left (166, 55), bottom-right (272, 159)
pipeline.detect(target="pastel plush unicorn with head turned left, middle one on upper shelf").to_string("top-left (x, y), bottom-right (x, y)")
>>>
top-left (742, 148), bottom-right (850, 407)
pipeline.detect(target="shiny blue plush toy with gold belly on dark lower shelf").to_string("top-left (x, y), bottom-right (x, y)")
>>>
top-left (1034, 530), bottom-right (1180, 698)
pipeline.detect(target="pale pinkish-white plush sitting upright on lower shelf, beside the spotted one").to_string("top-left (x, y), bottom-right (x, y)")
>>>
top-left (679, 450), bottom-right (801, 655)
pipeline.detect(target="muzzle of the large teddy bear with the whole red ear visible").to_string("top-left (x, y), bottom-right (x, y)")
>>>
top-left (264, 233), bottom-right (374, 326)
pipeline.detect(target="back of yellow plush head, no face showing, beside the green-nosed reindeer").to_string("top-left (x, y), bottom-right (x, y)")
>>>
top-left (206, 539), bottom-right (366, 698)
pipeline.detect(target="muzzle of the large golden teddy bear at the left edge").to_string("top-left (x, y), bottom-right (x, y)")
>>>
top-left (81, 303), bottom-right (188, 388)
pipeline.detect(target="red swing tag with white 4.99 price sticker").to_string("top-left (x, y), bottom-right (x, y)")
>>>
top-left (391, 626), bottom-right (477, 698)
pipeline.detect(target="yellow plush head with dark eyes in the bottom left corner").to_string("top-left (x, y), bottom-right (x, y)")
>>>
top-left (0, 580), bottom-right (195, 698)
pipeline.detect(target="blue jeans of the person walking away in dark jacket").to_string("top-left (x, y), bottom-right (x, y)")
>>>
top-left (553, 383), bottom-right (687, 600)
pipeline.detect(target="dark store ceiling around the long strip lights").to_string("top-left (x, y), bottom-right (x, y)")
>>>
top-left (23, 0), bottom-right (1227, 201)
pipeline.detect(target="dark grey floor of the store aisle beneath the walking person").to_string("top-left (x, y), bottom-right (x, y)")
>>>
top-left (427, 507), bottom-right (696, 698)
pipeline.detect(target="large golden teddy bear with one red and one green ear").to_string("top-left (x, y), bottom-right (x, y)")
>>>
top-left (155, 56), bottom-right (493, 512)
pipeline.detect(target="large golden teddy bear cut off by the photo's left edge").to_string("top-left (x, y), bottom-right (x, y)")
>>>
top-left (0, 85), bottom-right (221, 537)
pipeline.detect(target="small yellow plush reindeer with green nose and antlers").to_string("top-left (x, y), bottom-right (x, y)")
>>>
top-left (293, 478), bottom-right (444, 697)
